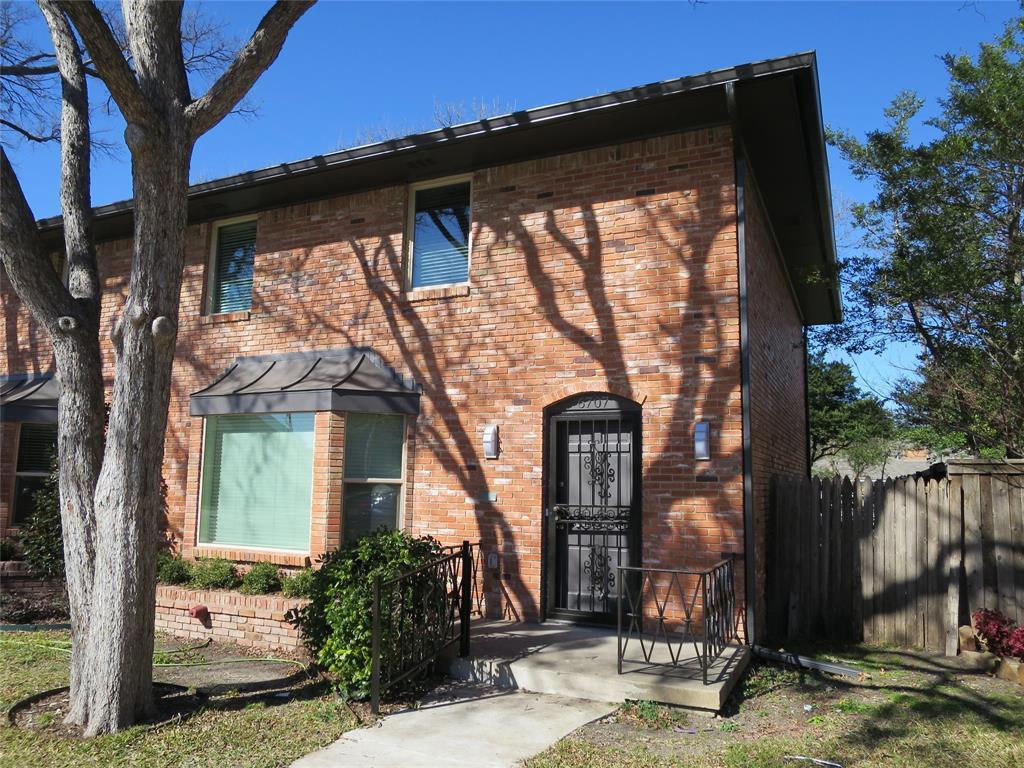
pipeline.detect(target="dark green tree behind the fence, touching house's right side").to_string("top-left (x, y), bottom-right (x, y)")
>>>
top-left (807, 353), bottom-right (893, 464)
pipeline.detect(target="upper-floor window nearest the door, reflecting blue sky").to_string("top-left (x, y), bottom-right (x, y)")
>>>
top-left (409, 181), bottom-right (470, 289)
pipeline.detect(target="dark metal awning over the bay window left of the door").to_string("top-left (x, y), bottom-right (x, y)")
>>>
top-left (190, 349), bottom-right (420, 416)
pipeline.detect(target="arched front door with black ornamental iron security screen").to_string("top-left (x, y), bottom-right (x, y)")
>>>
top-left (545, 395), bottom-right (641, 624)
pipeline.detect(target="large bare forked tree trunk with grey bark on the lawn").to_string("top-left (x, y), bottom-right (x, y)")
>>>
top-left (0, 0), bottom-right (311, 735)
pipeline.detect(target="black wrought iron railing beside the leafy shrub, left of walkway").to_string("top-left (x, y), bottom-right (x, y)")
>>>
top-left (370, 542), bottom-right (482, 713)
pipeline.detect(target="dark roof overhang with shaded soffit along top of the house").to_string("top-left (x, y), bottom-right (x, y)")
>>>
top-left (39, 52), bottom-right (842, 324)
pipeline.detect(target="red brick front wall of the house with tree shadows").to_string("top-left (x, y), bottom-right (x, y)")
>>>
top-left (5, 127), bottom-right (742, 616)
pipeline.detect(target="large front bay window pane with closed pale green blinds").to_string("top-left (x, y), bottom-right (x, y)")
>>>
top-left (199, 414), bottom-right (313, 552)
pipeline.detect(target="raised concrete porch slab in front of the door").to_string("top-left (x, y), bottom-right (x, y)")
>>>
top-left (449, 621), bottom-right (751, 712)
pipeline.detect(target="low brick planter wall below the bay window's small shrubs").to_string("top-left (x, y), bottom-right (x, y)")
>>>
top-left (157, 585), bottom-right (308, 653)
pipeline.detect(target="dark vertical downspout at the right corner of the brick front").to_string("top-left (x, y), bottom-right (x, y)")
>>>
top-left (725, 83), bottom-right (758, 644)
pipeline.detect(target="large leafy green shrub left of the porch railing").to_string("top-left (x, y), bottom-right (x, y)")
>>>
top-left (290, 529), bottom-right (443, 696)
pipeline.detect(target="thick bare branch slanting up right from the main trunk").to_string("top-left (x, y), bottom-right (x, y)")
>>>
top-left (185, 0), bottom-right (313, 141)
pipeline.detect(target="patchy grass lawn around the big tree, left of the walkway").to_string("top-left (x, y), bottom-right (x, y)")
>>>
top-left (0, 632), bottom-right (357, 768)
